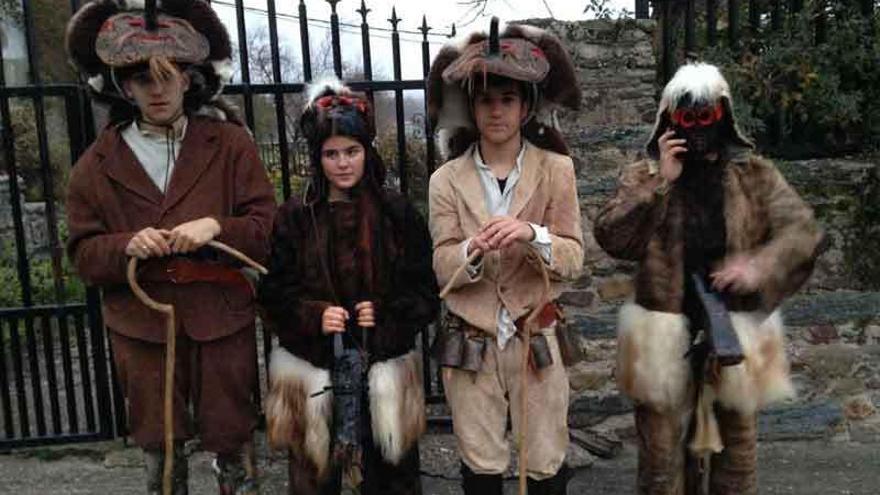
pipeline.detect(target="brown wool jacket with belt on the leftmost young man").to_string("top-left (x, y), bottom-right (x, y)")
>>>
top-left (67, 117), bottom-right (275, 342)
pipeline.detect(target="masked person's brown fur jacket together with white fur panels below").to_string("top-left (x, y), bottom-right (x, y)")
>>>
top-left (595, 153), bottom-right (822, 414)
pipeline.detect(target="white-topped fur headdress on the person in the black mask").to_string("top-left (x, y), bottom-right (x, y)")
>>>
top-left (646, 63), bottom-right (755, 159)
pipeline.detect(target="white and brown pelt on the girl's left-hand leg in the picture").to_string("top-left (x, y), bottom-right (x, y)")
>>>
top-left (266, 348), bottom-right (333, 478)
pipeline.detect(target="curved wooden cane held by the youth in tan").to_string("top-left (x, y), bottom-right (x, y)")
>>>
top-left (440, 246), bottom-right (550, 495)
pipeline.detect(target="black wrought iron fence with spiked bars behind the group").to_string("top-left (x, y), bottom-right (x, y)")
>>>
top-left (0, 0), bottom-right (454, 450)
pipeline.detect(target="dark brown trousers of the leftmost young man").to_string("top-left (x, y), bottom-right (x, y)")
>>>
top-left (110, 326), bottom-right (257, 454)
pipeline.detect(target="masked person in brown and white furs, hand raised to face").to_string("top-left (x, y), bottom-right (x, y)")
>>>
top-left (595, 64), bottom-right (821, 495)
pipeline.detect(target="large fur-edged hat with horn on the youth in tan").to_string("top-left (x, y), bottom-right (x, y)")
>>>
top-left (428, 17), bottom-right (581, 158)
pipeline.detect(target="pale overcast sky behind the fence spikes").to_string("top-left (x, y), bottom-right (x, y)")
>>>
top-left (212, 0), bottom-right (635, 82)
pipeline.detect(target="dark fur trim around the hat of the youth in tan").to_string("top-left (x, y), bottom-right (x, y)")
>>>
top-left (427, 24), bottom-right (581, 159)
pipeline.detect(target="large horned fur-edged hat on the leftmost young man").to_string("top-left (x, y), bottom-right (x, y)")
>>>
top-left (65, 0), bottom-right (233, 107)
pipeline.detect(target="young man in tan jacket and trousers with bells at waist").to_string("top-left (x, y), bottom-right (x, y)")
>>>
top-left (429, 20), bottom-right (583, 495)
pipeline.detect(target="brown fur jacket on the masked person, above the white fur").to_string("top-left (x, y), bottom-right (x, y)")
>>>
top-left (594, 154), bottom-right (822, 313)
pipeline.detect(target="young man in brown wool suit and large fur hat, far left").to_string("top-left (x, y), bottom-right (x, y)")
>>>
top-left (67, 0), bottom-right (275, 495)
